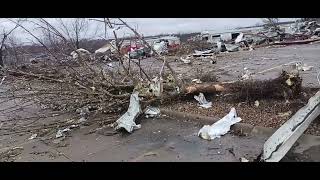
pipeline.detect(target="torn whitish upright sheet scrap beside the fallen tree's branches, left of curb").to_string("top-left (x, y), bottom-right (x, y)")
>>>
top-left (115, 92), bottom-right (141, 133)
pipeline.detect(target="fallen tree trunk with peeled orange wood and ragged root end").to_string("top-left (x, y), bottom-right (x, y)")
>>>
top-left (181, 71), bottom-right (302, 101)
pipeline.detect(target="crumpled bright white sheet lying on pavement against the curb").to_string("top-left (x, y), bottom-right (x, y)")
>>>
top-left (198, 108), bottom-right (241, 140)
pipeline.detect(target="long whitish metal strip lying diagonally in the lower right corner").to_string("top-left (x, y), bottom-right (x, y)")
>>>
top-left (261, 91), bottom-right (320, 162)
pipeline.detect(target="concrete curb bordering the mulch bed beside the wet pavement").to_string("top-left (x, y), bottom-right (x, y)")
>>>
top-left (160, 109), bottom-right (320, 153)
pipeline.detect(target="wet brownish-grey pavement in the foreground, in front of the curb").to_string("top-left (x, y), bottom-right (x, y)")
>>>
top-left (0, 118), bottom-right (264, 162)
